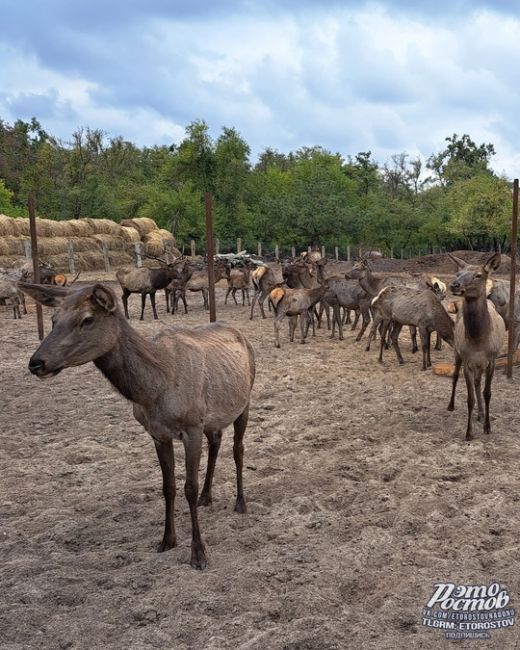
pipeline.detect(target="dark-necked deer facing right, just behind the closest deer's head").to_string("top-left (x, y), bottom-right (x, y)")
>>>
top-left (116, 257), bottom-right (183, 320)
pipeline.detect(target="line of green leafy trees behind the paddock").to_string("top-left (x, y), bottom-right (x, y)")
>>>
top-left (0, 118), bottom-right (512, 253)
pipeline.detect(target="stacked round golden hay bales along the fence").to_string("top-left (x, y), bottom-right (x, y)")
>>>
top-left (0, 215), bottom-right (180, 272)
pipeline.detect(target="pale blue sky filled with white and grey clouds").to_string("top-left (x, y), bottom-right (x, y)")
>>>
top-left (0, 0), bottom-right (520, 177)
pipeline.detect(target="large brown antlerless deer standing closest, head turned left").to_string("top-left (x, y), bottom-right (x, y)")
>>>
top-left (20, 283), bottom-right (255, 569)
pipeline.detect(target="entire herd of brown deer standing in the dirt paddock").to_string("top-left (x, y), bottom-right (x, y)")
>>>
top-left (4, 243), bottom-right (520, 569)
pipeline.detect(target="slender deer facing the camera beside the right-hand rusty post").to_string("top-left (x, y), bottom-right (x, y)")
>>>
top-left (448, 253), bottom-right (506, 440)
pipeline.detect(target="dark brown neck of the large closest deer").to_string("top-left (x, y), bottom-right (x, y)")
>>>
top-left (94, 319), bottom-right (164, 406)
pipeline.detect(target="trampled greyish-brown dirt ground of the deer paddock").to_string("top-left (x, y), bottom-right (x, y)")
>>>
top-left (0, 274), bottom-right (520, 650)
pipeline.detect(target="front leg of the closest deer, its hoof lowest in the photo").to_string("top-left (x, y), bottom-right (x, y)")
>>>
top-left (182, 429), bottom-right (208, 569)
